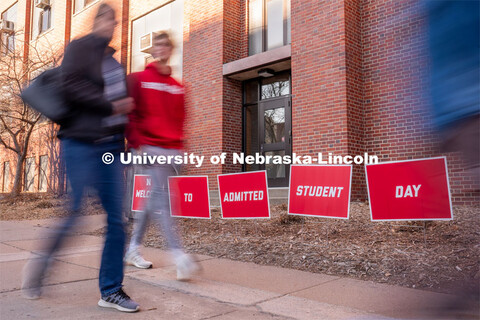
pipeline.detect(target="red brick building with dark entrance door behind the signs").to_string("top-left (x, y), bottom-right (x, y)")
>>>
top-left (0, 0), bottom-right (479, 204)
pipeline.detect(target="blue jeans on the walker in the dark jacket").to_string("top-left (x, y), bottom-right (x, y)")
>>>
top-left (41, 139), bottom-right (125, 296)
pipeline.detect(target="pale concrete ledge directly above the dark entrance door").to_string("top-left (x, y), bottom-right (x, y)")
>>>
top-left (223, 45), bottom-right (292, 80)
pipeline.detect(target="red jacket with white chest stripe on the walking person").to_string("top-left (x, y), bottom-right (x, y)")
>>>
top-left (126, 62), bottom-right (185, 149)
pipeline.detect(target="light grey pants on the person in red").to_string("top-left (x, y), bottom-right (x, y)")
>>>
top-left (131, 145), bottom-right (182, 250)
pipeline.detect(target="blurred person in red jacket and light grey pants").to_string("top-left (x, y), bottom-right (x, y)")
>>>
top-left (125, 32), bottom-right (198, 280)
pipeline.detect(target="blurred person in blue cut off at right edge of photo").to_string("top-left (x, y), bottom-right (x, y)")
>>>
top-left (427, 0), bottom-right (480, 185)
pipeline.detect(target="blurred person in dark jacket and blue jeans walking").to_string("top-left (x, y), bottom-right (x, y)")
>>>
top-left (22, 4), bottom-right (139, 312)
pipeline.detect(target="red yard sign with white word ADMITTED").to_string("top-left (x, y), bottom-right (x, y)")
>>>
top-left (217, 171), bottom-right (270, 219)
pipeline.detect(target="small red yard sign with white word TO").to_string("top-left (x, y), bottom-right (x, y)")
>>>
top-left (168, 176), bottom-right (210, 219)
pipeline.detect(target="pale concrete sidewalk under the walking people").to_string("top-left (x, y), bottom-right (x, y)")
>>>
top-left (0, 215), bottom-right (476, 320)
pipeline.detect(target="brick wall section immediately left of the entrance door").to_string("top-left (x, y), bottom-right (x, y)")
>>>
top-left (183, 0), bottom-right (223, 188)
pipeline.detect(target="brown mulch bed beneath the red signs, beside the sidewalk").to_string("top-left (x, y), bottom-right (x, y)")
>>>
top-left (139, 202), bottom-right (480, 292)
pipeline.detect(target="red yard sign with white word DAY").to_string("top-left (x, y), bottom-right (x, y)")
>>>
top-left (365, 157), bottom-right (453, 221)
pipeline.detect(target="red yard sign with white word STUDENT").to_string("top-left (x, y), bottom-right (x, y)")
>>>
top-left (288, 165), bottom-right (352, 219)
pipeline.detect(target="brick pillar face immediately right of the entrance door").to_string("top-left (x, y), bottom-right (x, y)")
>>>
top-left (291, 0), bottom-right (349, 165)
